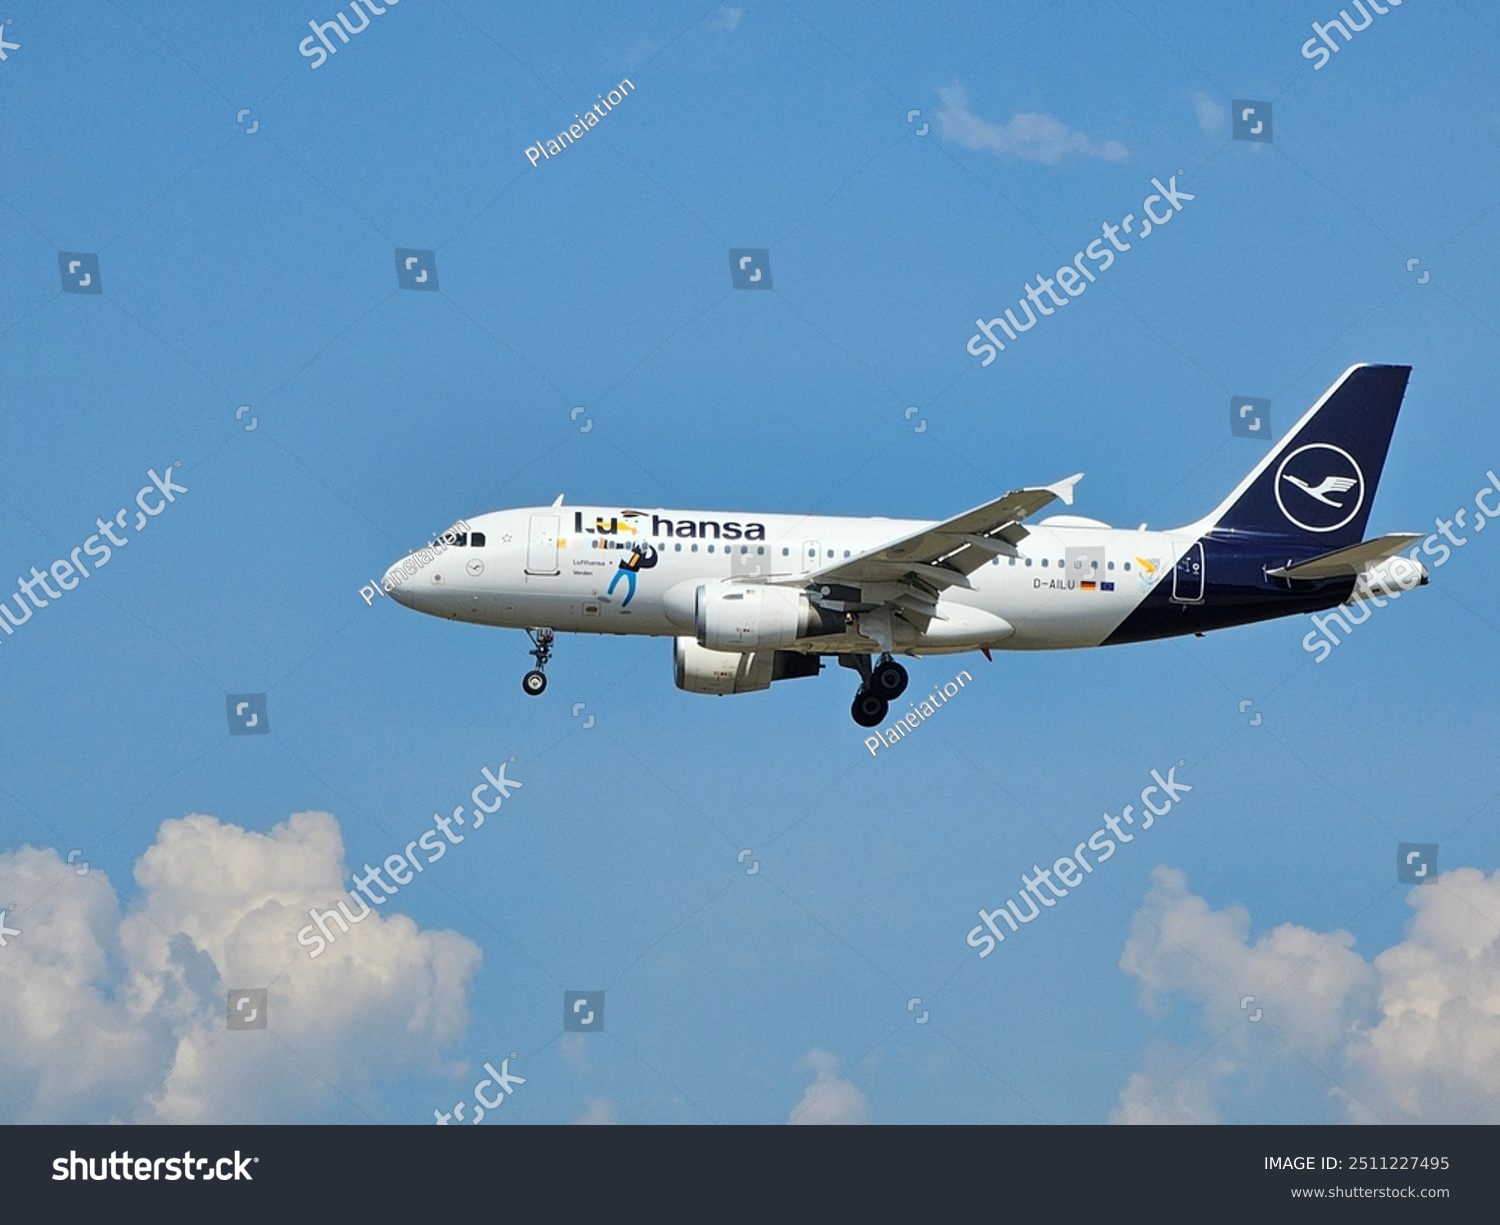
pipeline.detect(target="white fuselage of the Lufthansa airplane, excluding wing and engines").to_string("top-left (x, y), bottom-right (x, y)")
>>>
top-left (384, 505), bottom-right (1203, 655)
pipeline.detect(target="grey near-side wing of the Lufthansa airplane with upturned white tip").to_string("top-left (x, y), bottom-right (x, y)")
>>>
top-left (795, 472), bottom-right (1083, 651)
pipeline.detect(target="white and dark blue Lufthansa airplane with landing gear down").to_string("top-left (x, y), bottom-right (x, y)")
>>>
top-left (381, 364), bottom-right (1430, 727)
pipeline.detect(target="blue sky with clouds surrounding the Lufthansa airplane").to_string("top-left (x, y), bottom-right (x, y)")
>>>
top-left (0, 0), bottom-right (1500, 1123)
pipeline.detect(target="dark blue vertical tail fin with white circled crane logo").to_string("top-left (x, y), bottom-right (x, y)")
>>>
top-left (1200, 366), bottom-right (1412, 549)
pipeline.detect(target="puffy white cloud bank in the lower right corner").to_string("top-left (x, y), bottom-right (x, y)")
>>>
top-left (1112, 868), bottom-right (1500, 1123)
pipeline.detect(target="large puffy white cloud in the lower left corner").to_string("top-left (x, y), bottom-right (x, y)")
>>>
top-left (0, 813), bottom-right (480, 1123)
